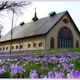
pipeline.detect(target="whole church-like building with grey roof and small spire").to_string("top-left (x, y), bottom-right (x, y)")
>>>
top-left (0, 11), bottom-right (80, 52)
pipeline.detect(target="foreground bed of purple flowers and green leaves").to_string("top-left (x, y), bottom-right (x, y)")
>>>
top-left (0, 54), bottom-right (80, 78)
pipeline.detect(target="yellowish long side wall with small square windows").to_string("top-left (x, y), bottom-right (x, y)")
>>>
top-left (0, 36), bottom-right (45, 52)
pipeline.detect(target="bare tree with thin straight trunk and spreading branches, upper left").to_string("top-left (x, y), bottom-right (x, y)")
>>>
top-left (0, 1), bottom-right (31, 54)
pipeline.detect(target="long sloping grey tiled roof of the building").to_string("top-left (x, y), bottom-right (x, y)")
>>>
top-left (0, 11), bottom-right (79, 42)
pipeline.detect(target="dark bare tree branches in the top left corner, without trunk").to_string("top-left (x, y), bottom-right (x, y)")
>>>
top-left (0, 1), bottom-right (31, 11)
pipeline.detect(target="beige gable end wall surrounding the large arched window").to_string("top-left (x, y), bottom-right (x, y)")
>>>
top-left (46, 12), bottom-right (80, 48)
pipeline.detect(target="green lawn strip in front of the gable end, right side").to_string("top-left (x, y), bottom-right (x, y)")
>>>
top-left (30, 48), bottom-right (80, 56)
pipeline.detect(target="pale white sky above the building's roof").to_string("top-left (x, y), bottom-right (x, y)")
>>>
top-left (0, 0), bottom-right (80, 35)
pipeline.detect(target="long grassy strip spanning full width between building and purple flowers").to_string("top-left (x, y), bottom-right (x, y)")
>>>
top-left (0, 48), bottom-right (80, 58)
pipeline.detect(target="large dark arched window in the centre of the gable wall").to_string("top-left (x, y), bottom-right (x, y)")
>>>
top-left (58, 27), bottom-right (73, 48)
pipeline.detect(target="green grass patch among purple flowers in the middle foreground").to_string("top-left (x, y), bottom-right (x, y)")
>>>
top-left (24, 62), bottom-right (55, 78)
